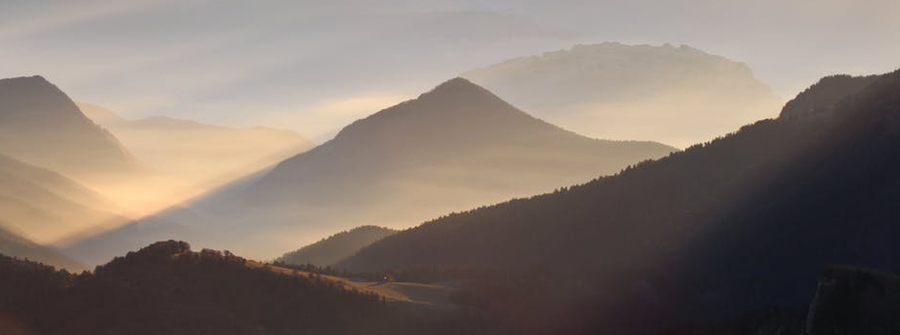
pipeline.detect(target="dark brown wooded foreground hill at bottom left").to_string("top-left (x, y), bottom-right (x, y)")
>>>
top-left (0, 241), bottom-right (458, 335)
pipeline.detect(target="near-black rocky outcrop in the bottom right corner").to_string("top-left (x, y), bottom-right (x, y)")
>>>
top-left (806, 266), bottom-right (900, 335)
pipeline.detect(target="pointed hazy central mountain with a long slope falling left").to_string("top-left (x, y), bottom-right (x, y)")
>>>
top-left (70, 78), bottom-right (675, 263)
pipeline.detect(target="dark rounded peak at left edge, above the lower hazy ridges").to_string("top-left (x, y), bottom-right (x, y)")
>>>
top-left (0, 76), bottom-right (140, 181)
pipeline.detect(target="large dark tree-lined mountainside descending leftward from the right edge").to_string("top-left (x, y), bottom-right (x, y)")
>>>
top-left (338, 71), bottom-right (900, 334)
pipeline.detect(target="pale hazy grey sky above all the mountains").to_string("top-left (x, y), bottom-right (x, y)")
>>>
top-left (0, 0), bottom-right (900, 139)
